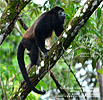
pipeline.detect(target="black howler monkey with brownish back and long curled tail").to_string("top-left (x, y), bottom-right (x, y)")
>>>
top-left (17, 6), bottom-right (66, 94)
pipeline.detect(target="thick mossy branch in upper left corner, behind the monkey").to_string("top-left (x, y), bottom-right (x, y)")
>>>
top-left (0, 0), bottom-right (31, 45)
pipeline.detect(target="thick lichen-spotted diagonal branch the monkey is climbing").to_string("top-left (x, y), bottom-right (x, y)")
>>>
top-left (11, 0), bottom-right (102, 100)
